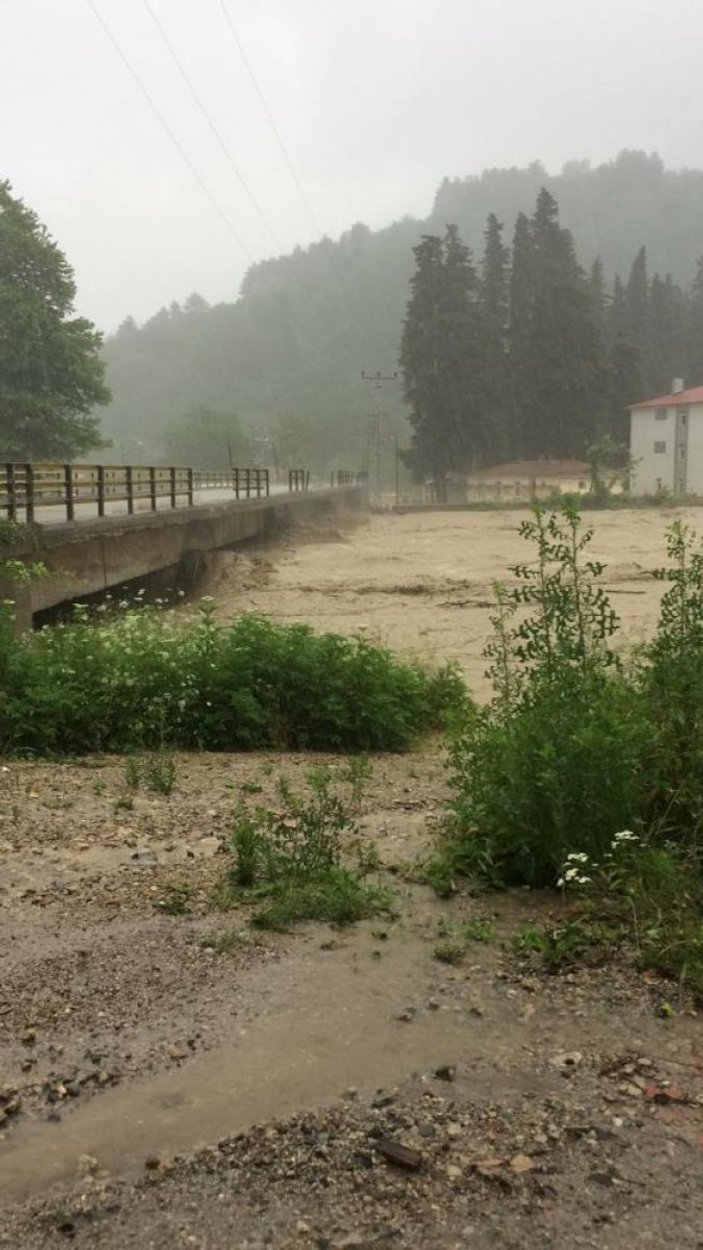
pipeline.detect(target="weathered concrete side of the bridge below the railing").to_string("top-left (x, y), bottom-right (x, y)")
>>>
top-left (0, 486), bottom-right (367, 631)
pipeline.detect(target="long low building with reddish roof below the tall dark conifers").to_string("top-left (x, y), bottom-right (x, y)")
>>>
top-left (465, 460), bottom-right (590, 503)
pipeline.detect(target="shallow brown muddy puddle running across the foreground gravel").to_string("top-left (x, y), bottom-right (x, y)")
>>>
top-left (0, 926), bottom-right (500, 1198)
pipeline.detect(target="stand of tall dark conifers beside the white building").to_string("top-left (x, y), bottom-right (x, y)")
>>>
top-left (400, 188), bottom-right (703, 491)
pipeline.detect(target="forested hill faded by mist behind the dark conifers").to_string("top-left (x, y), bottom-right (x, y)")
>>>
top-left (103, 153), bottom-right (703, 468)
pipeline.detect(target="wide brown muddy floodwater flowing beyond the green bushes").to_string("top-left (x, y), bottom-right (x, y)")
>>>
top-left (206, 509), bottom-right (703, 698)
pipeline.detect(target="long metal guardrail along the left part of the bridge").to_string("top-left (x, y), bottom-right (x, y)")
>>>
top-left (0, 463), bottom-right (270, 524)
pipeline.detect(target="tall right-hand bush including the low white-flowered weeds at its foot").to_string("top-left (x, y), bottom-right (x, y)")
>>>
top-left (425, 503), bottom-right (703, 996)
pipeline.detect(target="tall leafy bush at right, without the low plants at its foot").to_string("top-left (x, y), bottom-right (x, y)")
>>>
top-left (432, 505), bottom-right (703, 893)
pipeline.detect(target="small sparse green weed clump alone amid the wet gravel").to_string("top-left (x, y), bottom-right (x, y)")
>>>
top-left (220, 764), bottom-right (390, 931)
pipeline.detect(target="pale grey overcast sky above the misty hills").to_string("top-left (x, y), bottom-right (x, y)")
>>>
top-left (5, 0), bottom-right (703, 330)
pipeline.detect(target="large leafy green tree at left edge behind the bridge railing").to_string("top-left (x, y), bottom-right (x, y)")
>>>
top-left (0, 183), bottom-right (110, 460)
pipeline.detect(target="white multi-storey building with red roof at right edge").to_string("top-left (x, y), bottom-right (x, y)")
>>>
top-left (629, 378), bottom-right (703, 495)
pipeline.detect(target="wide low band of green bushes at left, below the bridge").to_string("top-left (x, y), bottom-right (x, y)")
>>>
top-left (0, 600), bottom-right (465, 755)
